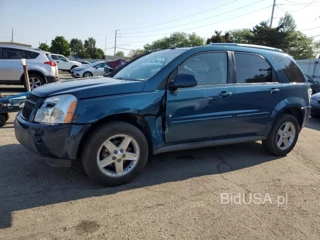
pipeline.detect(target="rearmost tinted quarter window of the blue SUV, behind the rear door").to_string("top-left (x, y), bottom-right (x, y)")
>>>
top-left (274, 56), bottom-right (306, 83)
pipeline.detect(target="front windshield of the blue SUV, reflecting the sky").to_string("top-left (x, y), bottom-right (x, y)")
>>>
top-left (113, 49), bottom-right (188, 81)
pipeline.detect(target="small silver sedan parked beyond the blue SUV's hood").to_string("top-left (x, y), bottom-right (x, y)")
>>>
top-left (71, 61), bottom-right (110, 78)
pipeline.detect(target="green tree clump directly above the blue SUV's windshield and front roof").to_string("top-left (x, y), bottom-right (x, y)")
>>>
top-left (144, 32), bottom-right (204, 52)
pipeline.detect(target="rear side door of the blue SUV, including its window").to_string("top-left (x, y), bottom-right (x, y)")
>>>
top-left (231, 52), bottom-right (282, 137)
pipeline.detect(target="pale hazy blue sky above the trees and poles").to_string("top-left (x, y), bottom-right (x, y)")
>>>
top-left (0, 0), bottom-right (320, 55)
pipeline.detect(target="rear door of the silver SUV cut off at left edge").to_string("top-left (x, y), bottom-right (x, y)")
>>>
top-left (0, 48), bottom-right (24, 82)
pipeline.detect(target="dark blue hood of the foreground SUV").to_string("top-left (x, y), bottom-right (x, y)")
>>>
top-left (32, 77), bottom-right (145, 99)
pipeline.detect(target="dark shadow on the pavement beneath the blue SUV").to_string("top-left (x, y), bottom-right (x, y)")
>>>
top-left (0, 142), bottom-right (277, 228)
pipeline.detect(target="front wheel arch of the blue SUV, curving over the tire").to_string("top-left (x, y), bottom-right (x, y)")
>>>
top-left (77, 113), bottom-right (153, 157)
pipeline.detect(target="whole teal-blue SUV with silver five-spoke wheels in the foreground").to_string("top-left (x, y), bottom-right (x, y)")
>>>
top-left (15, 44), bottom-right (311, 185)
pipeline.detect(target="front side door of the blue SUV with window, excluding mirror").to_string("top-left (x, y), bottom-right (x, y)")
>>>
top-left (165, 52), bottom-right (234, 144)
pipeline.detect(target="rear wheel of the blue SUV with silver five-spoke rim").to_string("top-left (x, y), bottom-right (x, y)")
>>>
top-left (262, 114), bottom-right (300, 156)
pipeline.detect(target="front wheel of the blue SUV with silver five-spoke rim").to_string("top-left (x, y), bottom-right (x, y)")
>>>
top-left (81, 121), bottom-right (149, 186)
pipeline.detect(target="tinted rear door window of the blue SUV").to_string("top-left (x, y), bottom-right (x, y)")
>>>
top-left (235, 53), bottom-right (272, 83)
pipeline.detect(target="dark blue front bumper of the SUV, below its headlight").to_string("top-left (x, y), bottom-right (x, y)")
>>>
top-left (14, 113), bottom-right (90, 167)
